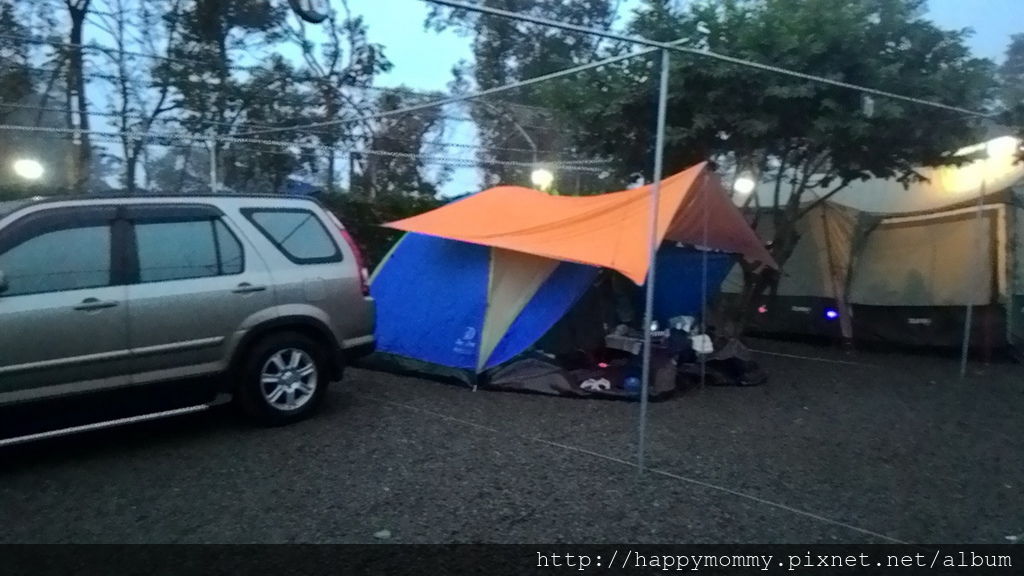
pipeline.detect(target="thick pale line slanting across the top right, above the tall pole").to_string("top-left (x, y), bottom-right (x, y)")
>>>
top-left (424, 0), bottom-right (994, 118)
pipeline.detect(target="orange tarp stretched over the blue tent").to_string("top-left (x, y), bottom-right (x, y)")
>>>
top-left (385, 163), bottom-right (777, 284)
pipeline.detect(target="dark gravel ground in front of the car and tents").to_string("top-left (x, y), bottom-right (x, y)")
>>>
top-left (0, 342), bottom-right (1024, 543)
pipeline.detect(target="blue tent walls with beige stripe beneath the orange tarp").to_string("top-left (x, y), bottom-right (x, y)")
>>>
top-left (371, 233), bottom-right (733, 373)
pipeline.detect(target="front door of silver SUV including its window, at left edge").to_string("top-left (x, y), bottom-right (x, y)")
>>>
top-left (0, 205), bottom-right (130, 403)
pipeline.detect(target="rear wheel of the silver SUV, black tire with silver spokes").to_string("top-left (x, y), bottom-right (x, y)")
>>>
top-left (237, 332), bottom-right (331, 426)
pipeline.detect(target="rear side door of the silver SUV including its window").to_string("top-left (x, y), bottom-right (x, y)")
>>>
top-left (121, 204), bottom-right (273, 383)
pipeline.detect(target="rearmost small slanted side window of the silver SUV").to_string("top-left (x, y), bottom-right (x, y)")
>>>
top-left (243, 208), bottom-right (341, 264)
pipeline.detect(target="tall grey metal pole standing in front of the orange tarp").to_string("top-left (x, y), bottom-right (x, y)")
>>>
top-left (637, 49), bottom-right (669, 476)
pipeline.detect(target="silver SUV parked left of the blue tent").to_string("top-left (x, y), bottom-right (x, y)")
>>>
top-left (0, 195), bottom-right (375, 434)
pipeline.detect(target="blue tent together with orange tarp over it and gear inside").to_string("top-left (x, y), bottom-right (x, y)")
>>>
top-left (364, 158), bottom-right (775, 399)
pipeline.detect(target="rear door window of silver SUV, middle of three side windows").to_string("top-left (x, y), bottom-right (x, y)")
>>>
top-left (135, 218), bottom-right (243, 283)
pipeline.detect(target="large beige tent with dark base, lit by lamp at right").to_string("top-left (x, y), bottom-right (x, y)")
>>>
top-left (723, 135), bottom-right (1024, 349)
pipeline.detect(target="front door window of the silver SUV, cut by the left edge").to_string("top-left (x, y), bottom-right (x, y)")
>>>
top-left (0, 222), bottom-right (112, 296)
